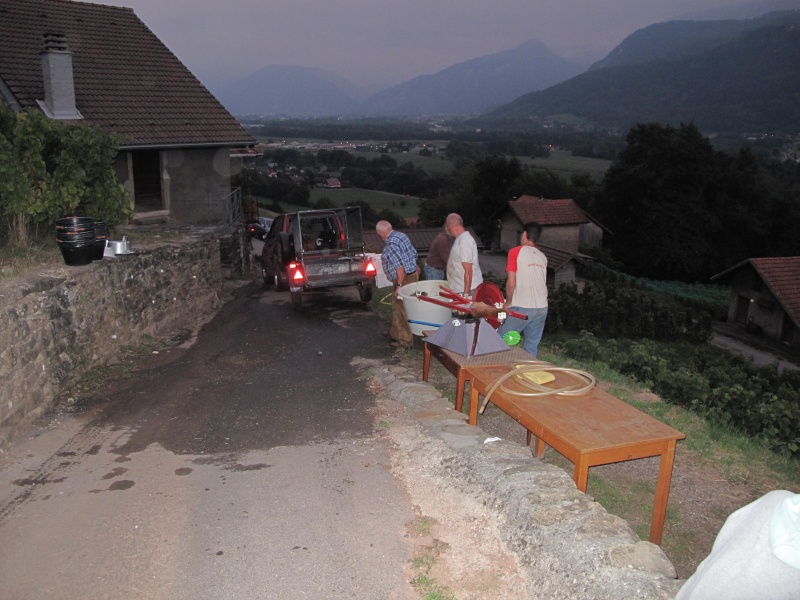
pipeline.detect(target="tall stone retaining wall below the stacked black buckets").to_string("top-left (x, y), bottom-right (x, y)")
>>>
top-left (0, 235), bottom-right (223, 453)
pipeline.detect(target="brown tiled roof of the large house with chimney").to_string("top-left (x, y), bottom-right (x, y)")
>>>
top-left (0, 0), bottom-right (255, 147)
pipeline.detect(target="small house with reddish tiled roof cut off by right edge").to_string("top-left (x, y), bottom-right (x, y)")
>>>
top-left (711, 256), bottom-right (800, 348)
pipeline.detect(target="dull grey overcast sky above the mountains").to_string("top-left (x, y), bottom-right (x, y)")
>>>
top-left (100, 0), bottom-right (780, 91)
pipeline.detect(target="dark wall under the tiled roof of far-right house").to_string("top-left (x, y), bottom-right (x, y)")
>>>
top-left (728, 268), bottom-right (800, 347)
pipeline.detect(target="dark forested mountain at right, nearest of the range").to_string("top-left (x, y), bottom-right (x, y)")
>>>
top-left (476, 11), bottom-right (800, 132)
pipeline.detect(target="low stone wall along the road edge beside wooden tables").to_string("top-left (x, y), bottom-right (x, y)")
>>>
top-left (355, 359), bottom-right (683, 600)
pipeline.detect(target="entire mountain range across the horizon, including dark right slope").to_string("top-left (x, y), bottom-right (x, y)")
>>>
top-left (212, 0), bottom-right (800, 132)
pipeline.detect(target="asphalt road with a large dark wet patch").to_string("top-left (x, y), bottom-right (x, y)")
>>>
top-left (0, 281), bottom-right (415, 600)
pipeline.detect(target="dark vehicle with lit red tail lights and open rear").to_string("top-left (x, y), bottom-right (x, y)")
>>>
top-left (261, 206), bottom-right (377, 309)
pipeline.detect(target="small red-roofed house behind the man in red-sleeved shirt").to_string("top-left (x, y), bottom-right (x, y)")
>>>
top-left (494, 196), bottom-right (606, 254)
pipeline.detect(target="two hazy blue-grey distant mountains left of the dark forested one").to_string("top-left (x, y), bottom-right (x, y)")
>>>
top-left (217, 41), bottom-right (588, 116)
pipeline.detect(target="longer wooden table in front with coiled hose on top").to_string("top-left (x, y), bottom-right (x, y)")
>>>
top-left (466, 366), bottom-right (686, 544)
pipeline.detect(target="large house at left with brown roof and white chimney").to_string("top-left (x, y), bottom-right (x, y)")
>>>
top-left (0, 0), bottom-right (255, 222)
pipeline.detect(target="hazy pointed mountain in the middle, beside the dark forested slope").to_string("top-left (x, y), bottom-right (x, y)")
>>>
top-left (361, 41), bottom-right (585, 116)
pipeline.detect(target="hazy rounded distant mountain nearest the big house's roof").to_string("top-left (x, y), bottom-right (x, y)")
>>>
top-left (216, 65), bottom-right (359, 116)
